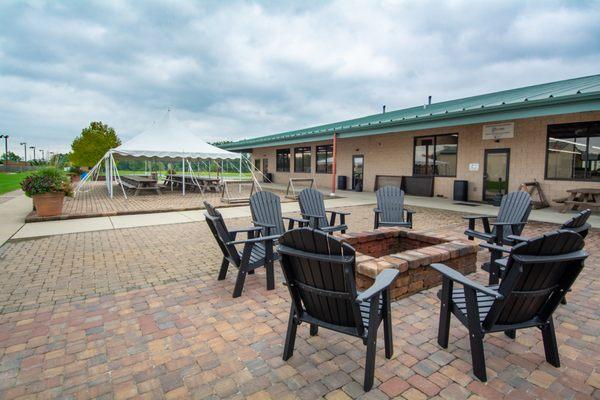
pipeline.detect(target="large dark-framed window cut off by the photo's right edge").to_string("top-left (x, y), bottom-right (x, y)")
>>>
top-left (546, 121), bottom-right (600, 181)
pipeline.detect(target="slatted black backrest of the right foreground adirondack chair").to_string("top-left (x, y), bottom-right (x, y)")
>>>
top-left (483, 230), bottom-right (587, 329)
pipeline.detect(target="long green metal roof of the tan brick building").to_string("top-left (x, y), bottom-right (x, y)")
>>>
top-left (220, 74), bottom-right (600, 150)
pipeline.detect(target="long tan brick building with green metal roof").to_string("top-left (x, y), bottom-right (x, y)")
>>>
top-left (223, 75), bottom-right (600, 205)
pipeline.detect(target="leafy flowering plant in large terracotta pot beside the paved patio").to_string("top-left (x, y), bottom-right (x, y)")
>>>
top-left (21, 167), bottom-right (73, 217)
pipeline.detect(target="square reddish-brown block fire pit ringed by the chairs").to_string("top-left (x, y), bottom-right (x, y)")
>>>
top-left (340, 227), bottom-right (478, 299)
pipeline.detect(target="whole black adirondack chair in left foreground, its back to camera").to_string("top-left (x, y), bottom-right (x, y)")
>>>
top-left (277, 228), bottom-right (399, 391)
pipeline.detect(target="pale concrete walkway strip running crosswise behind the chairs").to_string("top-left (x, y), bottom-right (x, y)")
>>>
top-left (9, 187), bottom-right (600, 243)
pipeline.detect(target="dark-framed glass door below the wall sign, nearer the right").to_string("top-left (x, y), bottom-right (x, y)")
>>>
top-left (483, 149), bottom-right (510, 201)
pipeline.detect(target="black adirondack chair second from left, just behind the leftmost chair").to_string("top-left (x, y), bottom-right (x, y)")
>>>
top-left (250, 191), bottom-right (308, 236)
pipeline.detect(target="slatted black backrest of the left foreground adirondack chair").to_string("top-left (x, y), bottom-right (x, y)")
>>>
top-left (278, 228), bottom-right (363, 335)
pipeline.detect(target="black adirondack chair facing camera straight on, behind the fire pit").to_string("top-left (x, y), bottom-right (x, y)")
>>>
top-left (373, 186), bottom-right (415, 229)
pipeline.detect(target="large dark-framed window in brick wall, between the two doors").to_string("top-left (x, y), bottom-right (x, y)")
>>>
top-left (413, 133), bottom-right (458, 176)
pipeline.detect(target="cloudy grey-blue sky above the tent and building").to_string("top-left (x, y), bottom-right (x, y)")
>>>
top-left (0, 0), bottom-right (600, 158)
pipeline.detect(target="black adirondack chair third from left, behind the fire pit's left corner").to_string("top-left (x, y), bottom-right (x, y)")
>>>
top-left (298, 188), bottom-right (350, 233)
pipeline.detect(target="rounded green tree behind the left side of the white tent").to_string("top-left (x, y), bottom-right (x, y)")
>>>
top-left (70, 121), bottom-right (121, 167)
